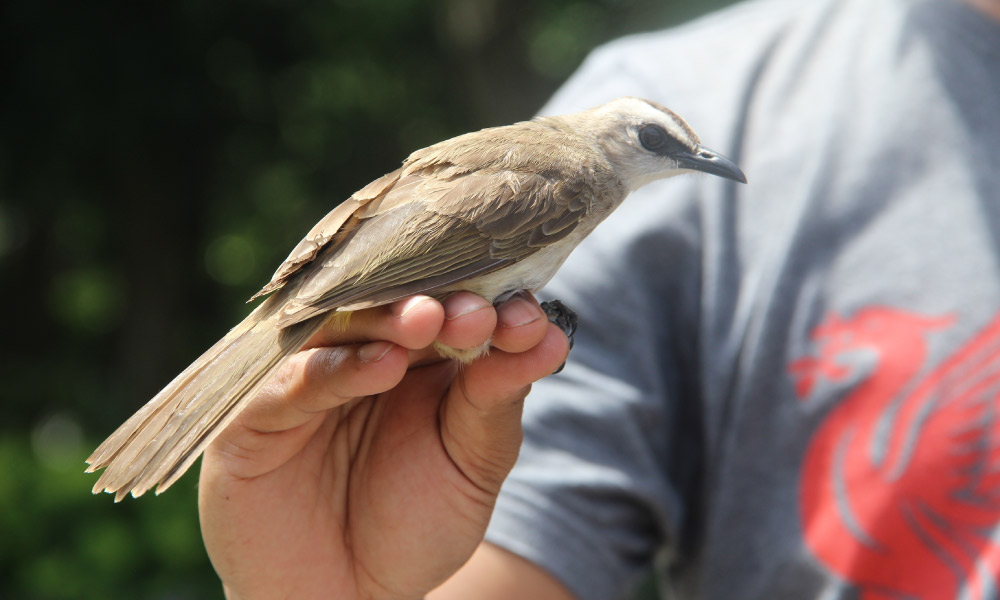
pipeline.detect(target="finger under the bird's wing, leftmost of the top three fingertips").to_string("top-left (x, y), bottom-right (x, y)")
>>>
top-left (304, 296), bottom-right (445, 349)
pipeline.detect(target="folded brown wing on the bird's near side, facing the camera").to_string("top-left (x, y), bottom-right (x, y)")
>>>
top-left (278, 163), bottom-right (594, 327)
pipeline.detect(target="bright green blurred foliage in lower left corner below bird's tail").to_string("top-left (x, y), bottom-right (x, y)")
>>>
top-left (0, 424), bottom-right (213, 600)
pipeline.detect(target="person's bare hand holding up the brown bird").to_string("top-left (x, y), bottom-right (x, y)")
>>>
top-left (199, 293), bottom-right (568, 599)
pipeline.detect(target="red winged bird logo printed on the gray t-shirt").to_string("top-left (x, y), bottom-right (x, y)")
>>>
top-left (789, 307), bottom-right (1000, 600)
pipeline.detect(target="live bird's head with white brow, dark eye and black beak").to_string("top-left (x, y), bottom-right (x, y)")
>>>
top-left (574, 97), bottom-right (747, 190)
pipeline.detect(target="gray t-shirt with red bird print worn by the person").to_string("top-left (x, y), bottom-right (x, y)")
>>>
top-left (487, 0), bottom-right (1000, 600)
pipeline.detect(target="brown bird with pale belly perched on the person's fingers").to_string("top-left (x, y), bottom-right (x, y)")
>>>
top-left (87, 97), bottom-right (746, 502)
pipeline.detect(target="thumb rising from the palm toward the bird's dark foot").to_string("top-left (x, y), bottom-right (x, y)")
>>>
top-left (441, 325), bottom-right (569, 496)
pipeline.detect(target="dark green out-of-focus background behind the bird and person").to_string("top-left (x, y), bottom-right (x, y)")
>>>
top-left (0, 0), bottom-right (728, 600)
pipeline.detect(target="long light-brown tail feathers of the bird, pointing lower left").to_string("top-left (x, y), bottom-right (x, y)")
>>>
top-left (87, 293), bottom-right (324, 502)
